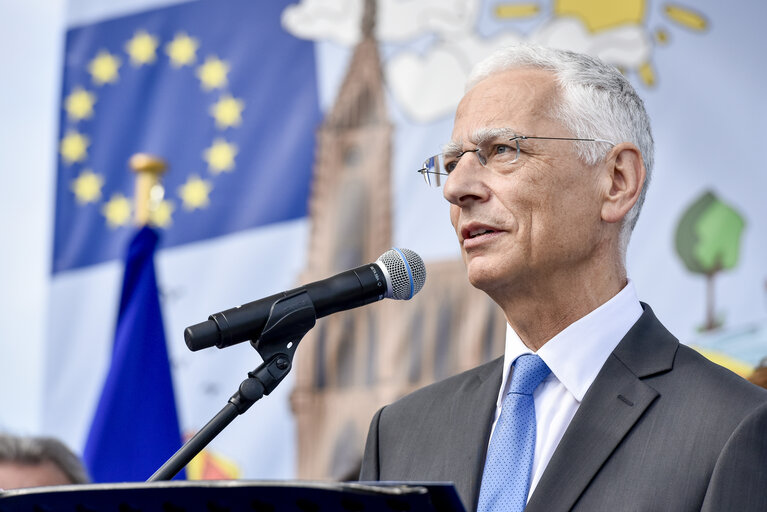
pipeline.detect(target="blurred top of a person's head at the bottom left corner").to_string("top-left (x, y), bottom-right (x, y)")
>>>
top-left (0, 434), bottom-right (90, 490)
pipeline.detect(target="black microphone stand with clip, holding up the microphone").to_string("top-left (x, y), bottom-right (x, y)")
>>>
top-left (147, 290), bottom-right (317, 482)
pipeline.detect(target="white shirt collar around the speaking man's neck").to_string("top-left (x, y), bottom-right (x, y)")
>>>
top-left (499, 279), bottom-right (642, 402)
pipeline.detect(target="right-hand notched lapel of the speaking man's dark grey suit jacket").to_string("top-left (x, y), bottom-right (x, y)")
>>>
top-left (525, 304), bottom-right (678, 512)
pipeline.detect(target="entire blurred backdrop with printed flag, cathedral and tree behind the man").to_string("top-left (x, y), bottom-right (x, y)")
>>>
top-left (0, 0), bottom-right (767, 479)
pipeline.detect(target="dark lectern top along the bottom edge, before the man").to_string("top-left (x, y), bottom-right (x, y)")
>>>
top-left (0, 480), bottom-right (465, 512)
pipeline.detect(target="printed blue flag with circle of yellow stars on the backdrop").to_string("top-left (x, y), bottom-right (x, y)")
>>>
top-left (53, 0), bottom-right (320, 274)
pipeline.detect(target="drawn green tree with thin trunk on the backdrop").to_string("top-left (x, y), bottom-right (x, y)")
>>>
top-left (675, 192), bottom-right (745, 331)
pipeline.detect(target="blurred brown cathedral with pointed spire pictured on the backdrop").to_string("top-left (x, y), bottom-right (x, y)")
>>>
top-left (292, 0), bottom-right (504, 480)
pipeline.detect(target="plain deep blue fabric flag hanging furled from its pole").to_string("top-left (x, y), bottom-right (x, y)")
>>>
top-left (84, 227), bottom-right (181, 482)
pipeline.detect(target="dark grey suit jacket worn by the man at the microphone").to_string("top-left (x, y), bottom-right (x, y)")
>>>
top-left (360, 304), bottom-right (767, 512)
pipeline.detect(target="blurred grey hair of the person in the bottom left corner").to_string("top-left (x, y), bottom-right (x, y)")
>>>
top-left (0, 434), bottom-right (90, 484)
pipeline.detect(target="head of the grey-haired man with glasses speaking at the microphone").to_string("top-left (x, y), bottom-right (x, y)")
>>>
top-left (421, 46), bottom-right (653, 346)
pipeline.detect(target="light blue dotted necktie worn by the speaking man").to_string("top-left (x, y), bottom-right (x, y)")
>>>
top-left (477, 354), bottom-right (551, 512)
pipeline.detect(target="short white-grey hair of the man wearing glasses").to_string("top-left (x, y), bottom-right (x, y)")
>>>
top-left (466, 45), bottom-right (654, 254)
